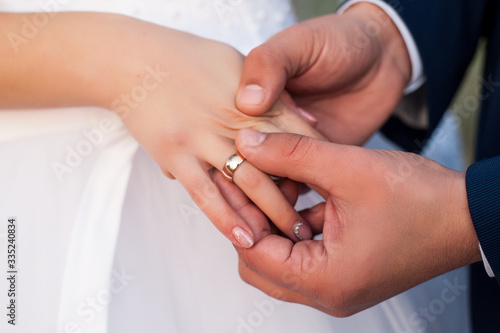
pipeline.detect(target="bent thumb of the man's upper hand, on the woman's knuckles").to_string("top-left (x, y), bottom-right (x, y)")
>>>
top-left (236, 26), bottom-right (312, 116)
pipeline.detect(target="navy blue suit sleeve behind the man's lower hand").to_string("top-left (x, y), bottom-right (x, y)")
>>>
top-left (466, 156), bottom-right (500, 284)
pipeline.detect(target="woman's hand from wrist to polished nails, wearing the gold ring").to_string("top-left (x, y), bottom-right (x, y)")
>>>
top-left (106, 18), bottom-right (324, 247)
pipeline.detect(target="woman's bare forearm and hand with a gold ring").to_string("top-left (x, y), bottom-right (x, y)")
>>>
top-left (0, 12), bottom-right (321, 247)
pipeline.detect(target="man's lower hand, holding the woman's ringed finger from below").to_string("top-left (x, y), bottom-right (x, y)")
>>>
top-left (227, 130), bottom-right (480, 316)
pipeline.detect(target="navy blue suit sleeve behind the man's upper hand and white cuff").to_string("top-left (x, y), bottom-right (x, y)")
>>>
top-left (376, 0), bottom-right (488, 152)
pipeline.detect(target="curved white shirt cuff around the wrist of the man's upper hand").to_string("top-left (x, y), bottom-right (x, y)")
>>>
top-left (337, 0), bottom-right (425, 95)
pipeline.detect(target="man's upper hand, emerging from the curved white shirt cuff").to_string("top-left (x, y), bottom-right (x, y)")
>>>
top-left (236, 3), bottom-right (411, 144)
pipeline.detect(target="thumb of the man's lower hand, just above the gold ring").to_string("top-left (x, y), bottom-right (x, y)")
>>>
top-left (236, 129), bottom-right (359, 189)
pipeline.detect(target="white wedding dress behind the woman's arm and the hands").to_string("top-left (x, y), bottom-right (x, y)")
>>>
top-left (0, 0), bottom-right (469, 333)
